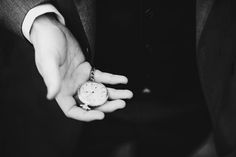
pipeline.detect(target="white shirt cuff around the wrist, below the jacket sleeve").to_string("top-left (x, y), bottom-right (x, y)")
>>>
top-left (21, 4), bottom-right (65, 42)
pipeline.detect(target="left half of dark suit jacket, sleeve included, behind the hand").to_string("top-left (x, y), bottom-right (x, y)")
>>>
top-left (0, 0), bottom-right (88, 157)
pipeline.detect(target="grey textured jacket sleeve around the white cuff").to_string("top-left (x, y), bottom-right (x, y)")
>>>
top-left (0, 0), bottom-right (49, 36)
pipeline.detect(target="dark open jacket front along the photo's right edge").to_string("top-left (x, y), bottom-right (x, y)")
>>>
top-left (197, 0), bottom-right (236, 157)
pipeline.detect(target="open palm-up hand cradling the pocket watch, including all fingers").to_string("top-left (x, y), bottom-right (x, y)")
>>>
top-left (30, 15), bottom-right (133, 121)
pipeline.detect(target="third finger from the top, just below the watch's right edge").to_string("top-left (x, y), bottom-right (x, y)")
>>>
top-left (96, 99), bottom-right (126, 112)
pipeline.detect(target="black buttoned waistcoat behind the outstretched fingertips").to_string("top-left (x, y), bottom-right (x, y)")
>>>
top-left (76, 0), bottom-right (211, 157)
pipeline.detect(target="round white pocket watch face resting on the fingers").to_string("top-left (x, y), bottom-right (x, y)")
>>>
top-left (78, 81), bottom-right (108, 106)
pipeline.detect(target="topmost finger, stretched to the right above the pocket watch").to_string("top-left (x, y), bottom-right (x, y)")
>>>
top-left (94, 69), bottom-right (128, 84)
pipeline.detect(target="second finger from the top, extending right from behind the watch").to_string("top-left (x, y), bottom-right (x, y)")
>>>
top-left (107, 88), bottom-right (133, 99)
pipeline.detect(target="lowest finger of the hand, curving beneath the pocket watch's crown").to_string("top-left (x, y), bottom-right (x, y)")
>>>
top-left (56, 95), bottom-right (104, 122)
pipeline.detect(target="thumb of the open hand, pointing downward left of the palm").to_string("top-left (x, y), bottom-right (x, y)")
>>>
top-left (35, 52), bottom-right (61, 99)
